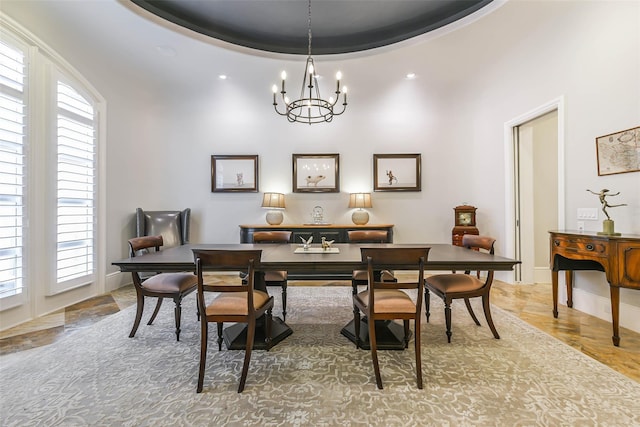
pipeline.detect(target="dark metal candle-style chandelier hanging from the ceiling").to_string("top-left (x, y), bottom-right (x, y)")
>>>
top-left (272, 0), bottom-right (347, 124)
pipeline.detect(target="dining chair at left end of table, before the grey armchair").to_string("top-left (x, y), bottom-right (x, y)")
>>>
top-left (128, 236), bottom-right (197, 341)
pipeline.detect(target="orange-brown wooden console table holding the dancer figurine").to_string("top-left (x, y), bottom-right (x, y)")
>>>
top-left (549, 230), bottom-right (640, 346)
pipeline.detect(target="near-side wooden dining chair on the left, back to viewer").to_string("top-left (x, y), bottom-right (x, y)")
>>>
top-left (193, 249), bottom-right (273, 393)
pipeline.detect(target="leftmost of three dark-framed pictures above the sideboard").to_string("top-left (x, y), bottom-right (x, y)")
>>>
top-left (211, 155), bottom-right (258, 193)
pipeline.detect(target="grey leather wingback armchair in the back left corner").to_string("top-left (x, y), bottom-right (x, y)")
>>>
top-left (136, 208), bottom-right (191, 248)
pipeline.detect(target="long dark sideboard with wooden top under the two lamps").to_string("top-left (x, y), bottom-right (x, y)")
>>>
top-left (240, 224), bottom-right (393, 280)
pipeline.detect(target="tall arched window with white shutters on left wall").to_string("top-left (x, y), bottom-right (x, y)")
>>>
top-left (0, 13), bottom-right (105, 318)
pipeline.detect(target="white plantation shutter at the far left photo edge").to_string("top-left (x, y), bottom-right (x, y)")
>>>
top-left (0, 41), bottom-right (26, 298)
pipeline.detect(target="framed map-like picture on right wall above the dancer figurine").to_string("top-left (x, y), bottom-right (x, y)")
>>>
top-left (596, 127), bottom-right (640, 176)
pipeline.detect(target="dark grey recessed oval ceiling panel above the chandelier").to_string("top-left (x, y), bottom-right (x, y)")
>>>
top-left (131, 0), bottom-right (492, 55)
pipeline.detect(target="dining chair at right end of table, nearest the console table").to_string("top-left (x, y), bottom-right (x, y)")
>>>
top-left (424, 234), bottom-right (500, 342)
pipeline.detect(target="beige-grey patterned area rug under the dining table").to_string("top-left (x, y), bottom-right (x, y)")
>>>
top-left (0, 287), bottom-right (640, 426)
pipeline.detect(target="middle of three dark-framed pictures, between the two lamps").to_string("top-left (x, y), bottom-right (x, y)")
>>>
top-left (293, 154), bottom-right (340, 193)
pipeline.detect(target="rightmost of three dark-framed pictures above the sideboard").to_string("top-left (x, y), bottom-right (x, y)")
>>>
top-left (373, 154), bottom-right (421, 191)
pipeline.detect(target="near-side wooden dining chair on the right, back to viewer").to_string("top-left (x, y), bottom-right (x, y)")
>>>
top-left (353, 247), bottom-right (430, 389)
